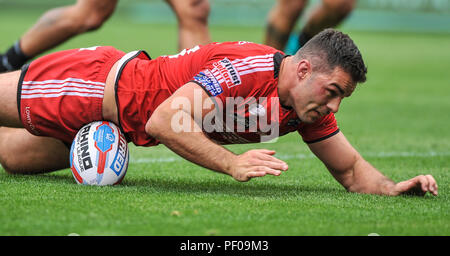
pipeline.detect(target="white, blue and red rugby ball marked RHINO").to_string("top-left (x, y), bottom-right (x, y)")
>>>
top-left (70, 121), bottom-right (129, 186)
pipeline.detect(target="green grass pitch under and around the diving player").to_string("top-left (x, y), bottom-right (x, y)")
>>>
top-left (0, 9), bottom-right (450, 236)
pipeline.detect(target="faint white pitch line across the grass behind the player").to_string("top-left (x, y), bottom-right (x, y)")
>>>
top-left (130, 151), bottom-right (450, 163)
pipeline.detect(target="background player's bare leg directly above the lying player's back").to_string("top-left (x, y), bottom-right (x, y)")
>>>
top-left (166, 0), bottom-right (211, 50)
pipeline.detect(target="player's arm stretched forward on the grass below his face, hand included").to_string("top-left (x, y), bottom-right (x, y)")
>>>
top-left (309, 132), bottom-right (438, 196)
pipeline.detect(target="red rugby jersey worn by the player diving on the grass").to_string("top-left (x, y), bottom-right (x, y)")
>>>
top-left (116, 41), bottom-right (339, 146)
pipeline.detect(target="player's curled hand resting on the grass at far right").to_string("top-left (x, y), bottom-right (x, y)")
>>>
top-left (393, 175), bottom-right (438, 196)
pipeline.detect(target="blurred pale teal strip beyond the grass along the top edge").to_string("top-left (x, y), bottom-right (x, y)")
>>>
top-left (0, 0), bottom-right (450, 33)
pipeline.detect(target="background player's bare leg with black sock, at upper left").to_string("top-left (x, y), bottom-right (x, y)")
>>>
top-left (0, 0), bottom-right (117, 72)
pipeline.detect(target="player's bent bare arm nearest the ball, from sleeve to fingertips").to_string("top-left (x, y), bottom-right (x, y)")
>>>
top-left (145, 82), bottom-right (288, 181)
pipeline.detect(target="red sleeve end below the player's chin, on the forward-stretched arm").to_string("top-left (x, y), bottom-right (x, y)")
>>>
top-left (297, 113), bottom-right (339, 144)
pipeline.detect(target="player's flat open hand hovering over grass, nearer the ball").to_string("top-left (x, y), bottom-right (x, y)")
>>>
top-left (231, 149), bottom-right (289, 181)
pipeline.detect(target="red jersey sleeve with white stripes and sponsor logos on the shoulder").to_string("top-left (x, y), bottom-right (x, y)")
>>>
top-left (187, 42), bottom-right (276, 109)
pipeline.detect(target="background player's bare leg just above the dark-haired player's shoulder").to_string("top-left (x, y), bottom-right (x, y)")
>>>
top-left (264, 0), bottom-right (308, 50)
